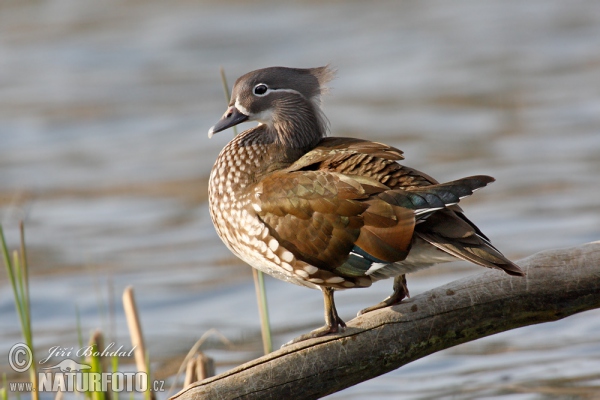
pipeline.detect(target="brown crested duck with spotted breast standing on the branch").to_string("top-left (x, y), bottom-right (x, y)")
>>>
top-left (208, 66), bottom-right (524, 343)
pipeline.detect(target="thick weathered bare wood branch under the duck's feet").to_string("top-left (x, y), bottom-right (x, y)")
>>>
top-left (174, 242), bottom-right (600, 400)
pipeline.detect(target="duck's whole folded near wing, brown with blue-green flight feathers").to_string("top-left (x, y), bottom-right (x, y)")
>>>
top-left (253, 165), bottom-right (491, 287)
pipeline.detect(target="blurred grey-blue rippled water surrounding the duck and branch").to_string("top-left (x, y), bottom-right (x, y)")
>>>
top-left (0, 0), bottom-right (600, 399)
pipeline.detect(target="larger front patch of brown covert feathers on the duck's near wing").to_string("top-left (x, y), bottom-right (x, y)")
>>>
top-left (258, 171), bottom-right (368, 270)
